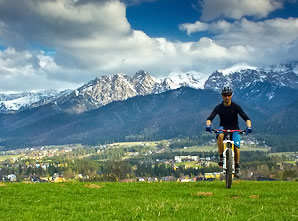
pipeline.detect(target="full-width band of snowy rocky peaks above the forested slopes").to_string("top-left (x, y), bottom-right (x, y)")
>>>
top-left (0, 62), bottom-right (298, 113)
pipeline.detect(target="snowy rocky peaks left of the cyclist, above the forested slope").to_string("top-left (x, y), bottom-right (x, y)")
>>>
top-left (0, 70), bottom-right (207, 113)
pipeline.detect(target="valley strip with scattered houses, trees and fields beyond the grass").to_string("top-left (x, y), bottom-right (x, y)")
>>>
top-left (0, 139), bottom-right (298, 182)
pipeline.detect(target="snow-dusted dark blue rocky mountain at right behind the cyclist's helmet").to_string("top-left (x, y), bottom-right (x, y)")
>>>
top-left (204, 62), bottom-right (298, 113)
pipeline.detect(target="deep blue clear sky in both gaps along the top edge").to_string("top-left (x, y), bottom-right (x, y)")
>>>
top-left (127, 0), bottom-right (298, 41)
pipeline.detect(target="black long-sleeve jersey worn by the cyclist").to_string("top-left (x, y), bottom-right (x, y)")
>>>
top-left (207, 102), bottom-right (250, 130)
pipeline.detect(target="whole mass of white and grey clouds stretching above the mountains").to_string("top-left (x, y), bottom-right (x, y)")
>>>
top-left (0, 0), bottom-right (298, 91)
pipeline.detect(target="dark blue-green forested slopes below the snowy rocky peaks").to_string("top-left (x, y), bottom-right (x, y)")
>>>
top-left (0, 87), bottom-right (298, 150)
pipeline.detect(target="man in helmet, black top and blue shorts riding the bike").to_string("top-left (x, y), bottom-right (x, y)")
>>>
top-left (206, 86), bottom-right (252, 177)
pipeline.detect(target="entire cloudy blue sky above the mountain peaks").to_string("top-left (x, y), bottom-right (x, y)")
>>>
top-left (0, 0), bottom-right (298, 92)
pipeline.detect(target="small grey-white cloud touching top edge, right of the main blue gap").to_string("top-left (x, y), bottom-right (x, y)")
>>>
top-left (201, 0), bottom-right (283, 21)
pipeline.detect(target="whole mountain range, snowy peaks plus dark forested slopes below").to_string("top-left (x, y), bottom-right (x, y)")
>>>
top-left (0, 62), bottom-right (298, 150)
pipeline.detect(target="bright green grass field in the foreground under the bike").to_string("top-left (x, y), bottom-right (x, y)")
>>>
top-left (0, 181), bottom-right (298, 221)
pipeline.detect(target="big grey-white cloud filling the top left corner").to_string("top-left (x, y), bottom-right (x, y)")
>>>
top-left (0, 0), bottom-right (131, 47)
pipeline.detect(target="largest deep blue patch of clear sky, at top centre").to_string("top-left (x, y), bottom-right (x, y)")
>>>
top-left (127, 0), bottom-right (199, 41)
